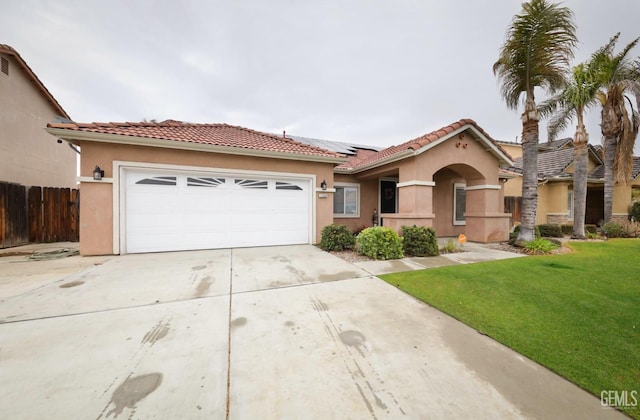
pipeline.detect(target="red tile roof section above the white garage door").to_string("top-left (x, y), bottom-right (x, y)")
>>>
top-left (47, 120), bottom-right (344, 158)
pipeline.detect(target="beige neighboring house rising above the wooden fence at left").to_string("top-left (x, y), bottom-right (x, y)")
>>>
top-left (0, 44), bottom-right (77, 188)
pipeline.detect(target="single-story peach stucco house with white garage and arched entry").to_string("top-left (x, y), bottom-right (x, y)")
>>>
top-left (47, 120), bottom-right (513, 255)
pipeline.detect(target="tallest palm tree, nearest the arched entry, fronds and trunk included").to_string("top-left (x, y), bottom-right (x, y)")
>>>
top-left (493, 0), bottom-right (577, 245)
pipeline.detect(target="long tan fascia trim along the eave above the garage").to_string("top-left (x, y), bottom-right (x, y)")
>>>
top-left (46, 128), bottom-right (347, 164)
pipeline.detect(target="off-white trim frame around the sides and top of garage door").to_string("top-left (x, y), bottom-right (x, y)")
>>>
top-left (112, 160), bottom-right (320, 255)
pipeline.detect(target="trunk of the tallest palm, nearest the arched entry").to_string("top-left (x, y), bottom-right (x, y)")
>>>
top-left (516, 115), bottom-right (539, 246)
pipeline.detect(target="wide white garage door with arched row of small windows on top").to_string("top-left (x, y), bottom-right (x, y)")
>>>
top-left (122, 169), bottom-right (312, 253)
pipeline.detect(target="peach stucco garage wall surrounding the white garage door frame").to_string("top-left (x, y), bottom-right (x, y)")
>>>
top-left (80, 142), bottom-right (333, 255)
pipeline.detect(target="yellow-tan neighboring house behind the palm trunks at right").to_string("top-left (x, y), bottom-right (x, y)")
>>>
top-left (500, 138), bottom-right (640, 224)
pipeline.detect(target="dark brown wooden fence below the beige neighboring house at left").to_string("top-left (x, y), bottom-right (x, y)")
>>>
top-left (0, 182), bottom-right (80, 248)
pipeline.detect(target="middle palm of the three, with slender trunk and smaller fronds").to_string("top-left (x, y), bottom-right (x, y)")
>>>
top-left (539, 63), bottom-right (601, 239)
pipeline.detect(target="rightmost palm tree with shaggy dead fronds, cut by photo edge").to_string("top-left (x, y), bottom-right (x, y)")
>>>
top-left (598, 33), bottom-right (640, 222)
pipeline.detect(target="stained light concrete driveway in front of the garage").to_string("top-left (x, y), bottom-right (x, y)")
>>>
top-left (0, 246), bottom-right (624, 419)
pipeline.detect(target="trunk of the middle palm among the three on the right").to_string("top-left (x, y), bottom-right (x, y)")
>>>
top-left (571, 139), bottom-right (589, 239)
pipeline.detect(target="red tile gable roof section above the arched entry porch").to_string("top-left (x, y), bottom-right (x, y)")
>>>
top-left (336, 118), bottom-right (511, 170)
